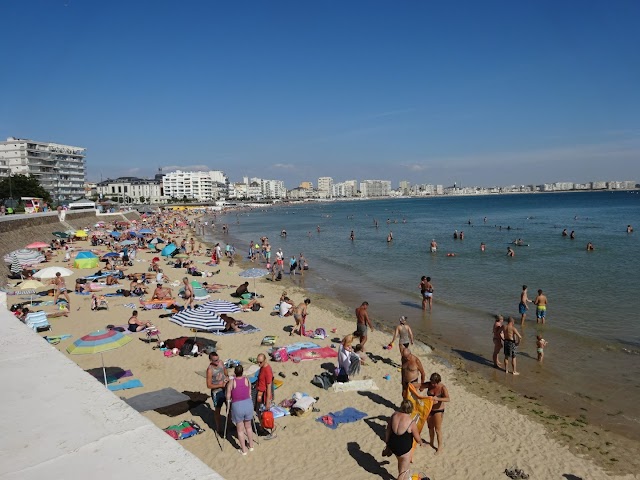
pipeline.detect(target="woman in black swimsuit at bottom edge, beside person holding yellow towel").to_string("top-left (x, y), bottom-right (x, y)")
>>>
top-left (382, 400), bottom-right (423, 480)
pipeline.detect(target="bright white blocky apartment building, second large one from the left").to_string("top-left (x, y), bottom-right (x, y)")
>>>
top-left (162, 170), bottom-right (229, 202)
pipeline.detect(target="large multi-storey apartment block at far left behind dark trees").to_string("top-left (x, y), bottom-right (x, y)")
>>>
top-left (0, 137), bottom-right (86, 202)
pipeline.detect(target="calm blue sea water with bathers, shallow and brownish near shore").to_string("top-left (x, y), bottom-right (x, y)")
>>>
top-left (210, 192), bottom-right (640, 438)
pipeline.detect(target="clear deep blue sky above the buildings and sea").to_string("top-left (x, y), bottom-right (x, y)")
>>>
top-left (0, 0), bottom-right (640, 188)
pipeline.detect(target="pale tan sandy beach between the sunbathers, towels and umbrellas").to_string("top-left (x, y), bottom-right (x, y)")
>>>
top-left (9, 214), bottom-right (640, 480)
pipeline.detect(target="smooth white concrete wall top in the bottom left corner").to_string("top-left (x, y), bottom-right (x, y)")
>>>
top-left (0, 300), bottom-right (222, 480)
